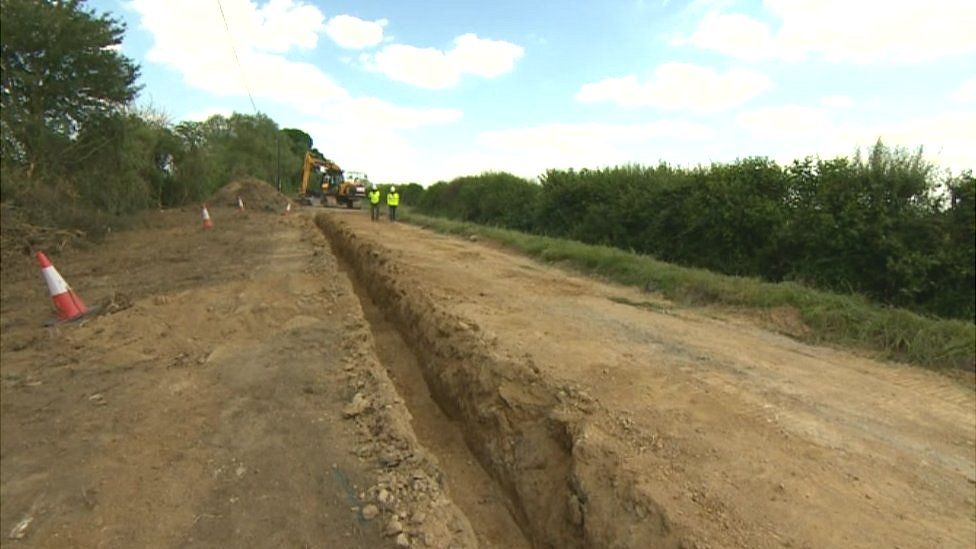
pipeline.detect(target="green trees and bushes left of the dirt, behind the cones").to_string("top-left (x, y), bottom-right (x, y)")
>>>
top-left (0, 0), bottom-right (322, 232)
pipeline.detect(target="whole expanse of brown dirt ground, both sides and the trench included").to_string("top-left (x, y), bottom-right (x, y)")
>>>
top-left (0, 195), bottom-right (976, 547)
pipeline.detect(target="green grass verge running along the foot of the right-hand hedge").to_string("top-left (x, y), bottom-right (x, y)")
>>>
top-left (403, 212), bottom-right (976, 371)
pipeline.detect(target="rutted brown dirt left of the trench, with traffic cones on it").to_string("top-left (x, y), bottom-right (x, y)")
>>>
top-left (0, 208), bottom-right (476, 548)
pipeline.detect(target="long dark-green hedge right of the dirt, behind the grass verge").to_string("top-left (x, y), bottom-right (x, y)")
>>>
top-left (418, 148), bottom-right (976, 321)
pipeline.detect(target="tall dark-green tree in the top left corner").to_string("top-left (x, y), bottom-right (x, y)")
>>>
top-left (0, 0), bottom-right (139, 175)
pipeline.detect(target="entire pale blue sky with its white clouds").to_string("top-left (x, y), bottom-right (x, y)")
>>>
top-left (90, 0), bottom-right (976, 184)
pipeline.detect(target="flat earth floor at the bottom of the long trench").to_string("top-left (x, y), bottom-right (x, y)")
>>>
top-left (337, 260), bottom-right (532, 549)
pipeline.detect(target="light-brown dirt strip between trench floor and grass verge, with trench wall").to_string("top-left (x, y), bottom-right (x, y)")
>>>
top-left (317, 209), bottom-right (976, 547)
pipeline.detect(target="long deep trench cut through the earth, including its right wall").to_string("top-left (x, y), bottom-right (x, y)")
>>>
top-left (315, 214), bottom-right (693, 548)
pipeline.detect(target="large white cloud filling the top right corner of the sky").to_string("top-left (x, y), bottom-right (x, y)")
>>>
top-left (672, 0), bottom-right (976, 63)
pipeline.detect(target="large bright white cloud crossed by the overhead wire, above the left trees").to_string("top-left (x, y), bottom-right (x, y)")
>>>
top-left (130, 0), bottom-right (462, 185)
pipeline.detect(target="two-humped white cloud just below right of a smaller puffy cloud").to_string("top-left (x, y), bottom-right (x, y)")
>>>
top-left (366, 33), bottom-right (525, 89)
